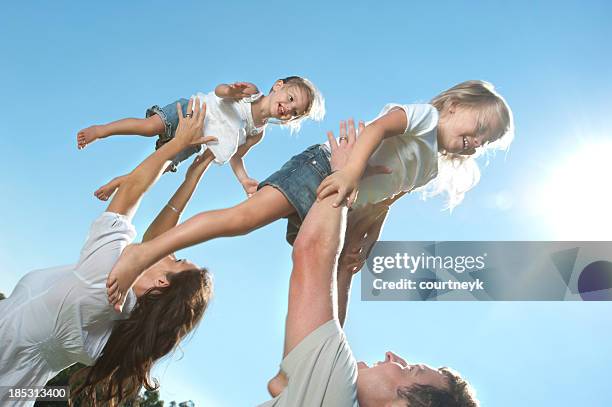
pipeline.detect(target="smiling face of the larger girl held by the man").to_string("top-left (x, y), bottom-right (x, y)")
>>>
top-left (438, 106), bottom-right (492, 155)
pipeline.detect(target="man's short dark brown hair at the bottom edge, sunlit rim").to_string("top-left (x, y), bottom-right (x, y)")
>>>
top-left (397, 367), bottom-right (479, 407)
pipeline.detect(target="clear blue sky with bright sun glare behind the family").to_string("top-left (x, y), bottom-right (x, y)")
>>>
top-left (0, 1), bottom-right (612, 407)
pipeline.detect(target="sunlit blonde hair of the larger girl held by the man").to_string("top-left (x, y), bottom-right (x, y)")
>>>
top-left (420, 80), bottom-right (514, 210)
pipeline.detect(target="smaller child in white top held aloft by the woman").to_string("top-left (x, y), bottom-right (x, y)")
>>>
top-left (77, 76), bottom-right (325, 200)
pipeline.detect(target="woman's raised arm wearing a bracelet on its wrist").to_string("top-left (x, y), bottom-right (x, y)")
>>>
top-left (142, 149), bottom-right (215, 242)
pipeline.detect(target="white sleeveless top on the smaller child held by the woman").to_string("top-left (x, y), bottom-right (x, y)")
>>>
top-left (192, 92), bottom-right (266, 164)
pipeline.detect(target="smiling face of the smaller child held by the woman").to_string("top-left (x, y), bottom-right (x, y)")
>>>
top-left (269, 81), bottom-right (310, 121)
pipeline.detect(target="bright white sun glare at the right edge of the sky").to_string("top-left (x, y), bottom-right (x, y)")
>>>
top-left (534, 139), bottom-right (612, 240)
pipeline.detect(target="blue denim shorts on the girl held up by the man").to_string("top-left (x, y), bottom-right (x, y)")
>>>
top-left (257, 144), bottom-right (331, 245)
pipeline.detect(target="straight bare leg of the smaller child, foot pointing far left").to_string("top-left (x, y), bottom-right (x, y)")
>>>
top-left (77, 114), bottom-right (165, 149)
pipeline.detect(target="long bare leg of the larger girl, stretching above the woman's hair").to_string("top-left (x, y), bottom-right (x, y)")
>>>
top-left (107, 186), bottom-right (295, 310)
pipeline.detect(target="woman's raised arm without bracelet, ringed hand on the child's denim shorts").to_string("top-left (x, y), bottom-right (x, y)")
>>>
top-left (106, 100), bottom-right (215, 217)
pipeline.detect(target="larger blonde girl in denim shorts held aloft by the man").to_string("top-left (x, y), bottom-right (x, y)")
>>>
top-left (107, 81), bottom-right (514, 310)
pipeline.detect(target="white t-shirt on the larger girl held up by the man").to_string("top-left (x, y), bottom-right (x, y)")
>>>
top-left (326, 103), bottom-right (438, 206)
